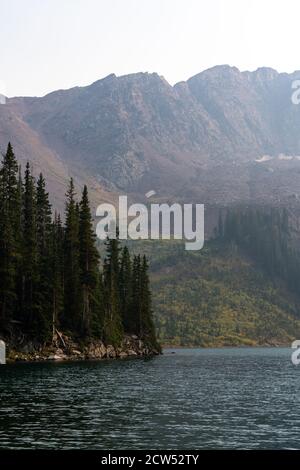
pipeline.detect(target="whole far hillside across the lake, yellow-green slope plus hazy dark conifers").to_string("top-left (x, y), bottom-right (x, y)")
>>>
top-left (133, 208), bottom-right (300, 346)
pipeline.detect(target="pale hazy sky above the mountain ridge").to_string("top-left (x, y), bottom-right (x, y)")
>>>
top-left (0, 0), bottom-right (300, 96)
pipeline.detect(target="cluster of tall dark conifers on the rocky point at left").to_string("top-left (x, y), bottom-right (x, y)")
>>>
top-left (0, 144), bottom-right (156, 345)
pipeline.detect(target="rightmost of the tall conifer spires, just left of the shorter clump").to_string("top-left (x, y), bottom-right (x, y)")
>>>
top-left (79, 186), bottom-right (99, 335)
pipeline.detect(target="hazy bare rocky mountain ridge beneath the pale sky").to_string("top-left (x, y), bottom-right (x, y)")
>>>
top-left (0, 66), bottom-right (300, 207)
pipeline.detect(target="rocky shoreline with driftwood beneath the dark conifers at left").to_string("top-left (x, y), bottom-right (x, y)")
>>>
top-left (7, 334), bottom-right (161, 362)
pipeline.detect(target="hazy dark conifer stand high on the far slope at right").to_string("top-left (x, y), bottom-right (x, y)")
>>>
top-left (217, 208), bottom-right (300, 293)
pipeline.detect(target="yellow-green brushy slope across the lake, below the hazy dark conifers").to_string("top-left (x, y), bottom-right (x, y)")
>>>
top-left (137, 242), bottom-right (300, 347)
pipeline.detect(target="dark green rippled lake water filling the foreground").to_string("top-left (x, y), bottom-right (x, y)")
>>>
top-left (0, 348), bottom-right (300, 450)
